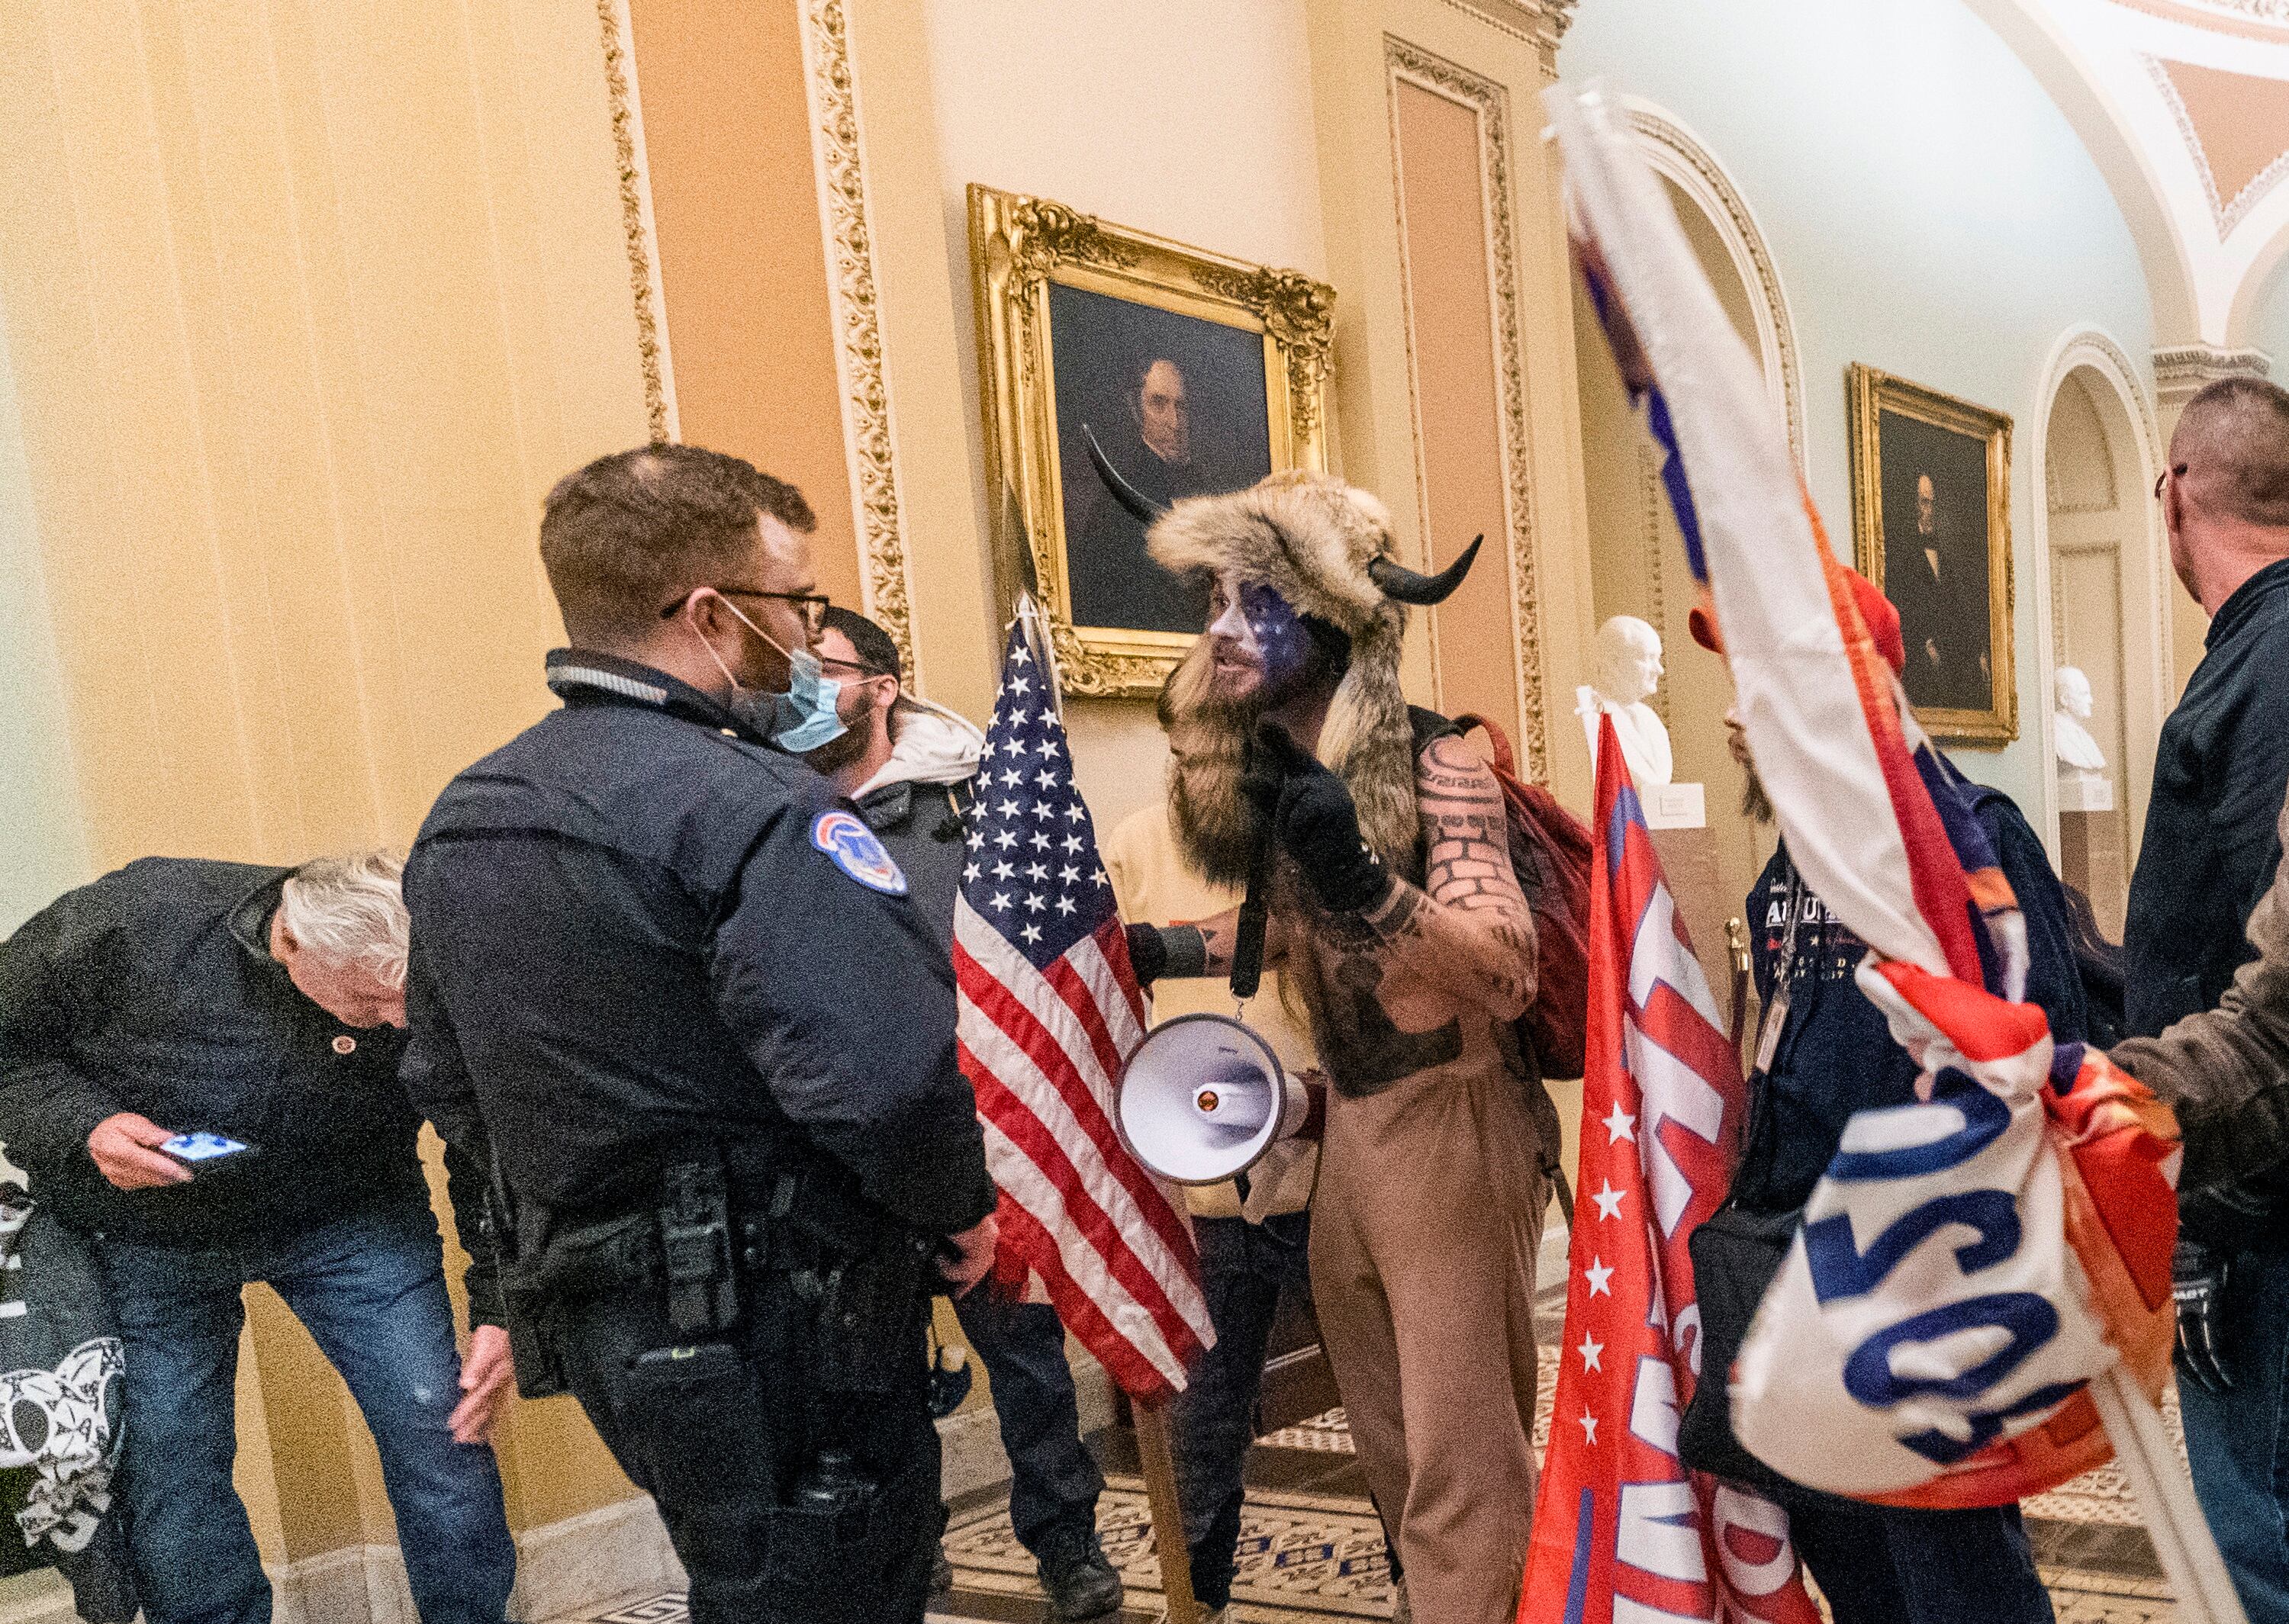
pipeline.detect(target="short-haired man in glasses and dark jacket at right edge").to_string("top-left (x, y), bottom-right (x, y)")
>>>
top-left (2122, 378), bottom-right (2289, 1619)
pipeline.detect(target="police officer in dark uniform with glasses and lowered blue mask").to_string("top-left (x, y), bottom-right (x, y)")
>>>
top-left (405, 446), bottom-right (993, 1624)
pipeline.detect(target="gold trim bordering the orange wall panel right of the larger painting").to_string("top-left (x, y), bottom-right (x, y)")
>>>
top-left (1383, 34), bottom-right (1550, 780)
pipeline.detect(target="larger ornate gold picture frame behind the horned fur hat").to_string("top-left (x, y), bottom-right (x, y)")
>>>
top-left (968, 185), bottom-right (1334, 698)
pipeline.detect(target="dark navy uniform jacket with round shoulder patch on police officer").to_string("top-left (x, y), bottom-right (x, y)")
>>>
top-left (405, 652), bottom-right (993, 1233)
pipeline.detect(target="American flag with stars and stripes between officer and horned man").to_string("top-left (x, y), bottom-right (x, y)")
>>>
top-left (955, 620), bottom-right (1215, 1402)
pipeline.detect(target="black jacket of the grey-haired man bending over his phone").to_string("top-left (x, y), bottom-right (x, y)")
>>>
top-left (0, 857), bottom-right (478, 1244)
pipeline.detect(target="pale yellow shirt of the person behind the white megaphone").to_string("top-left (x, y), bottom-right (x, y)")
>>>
top-left (1099, 803), bottom-right (1318, 1221)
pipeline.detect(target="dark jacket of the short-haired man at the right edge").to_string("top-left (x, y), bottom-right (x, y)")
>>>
top-left (2122, 561), bottom-right (2289, 1038)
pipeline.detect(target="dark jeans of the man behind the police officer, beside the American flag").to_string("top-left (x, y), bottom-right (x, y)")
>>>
top-left (955, 1288), bottom-right (1106, 1558)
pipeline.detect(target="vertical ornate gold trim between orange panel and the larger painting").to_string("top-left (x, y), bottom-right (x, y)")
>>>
top-left (803, 0), bottom-right (920, 682)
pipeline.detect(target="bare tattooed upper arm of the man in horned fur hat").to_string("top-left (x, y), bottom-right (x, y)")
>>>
top-left (1351, 739), bottom-right (1536, 1020)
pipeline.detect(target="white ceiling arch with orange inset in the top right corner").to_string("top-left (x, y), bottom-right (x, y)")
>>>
top-left (1969, 0), bottom-right (2289, 350)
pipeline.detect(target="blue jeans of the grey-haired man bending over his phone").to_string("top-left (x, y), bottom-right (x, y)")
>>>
top-left (101, 1208), bottom-right (517, 1624)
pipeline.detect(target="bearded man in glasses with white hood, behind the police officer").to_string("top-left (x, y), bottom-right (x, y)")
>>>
top-left (803, 606), bottom-right (1122, 1624)
